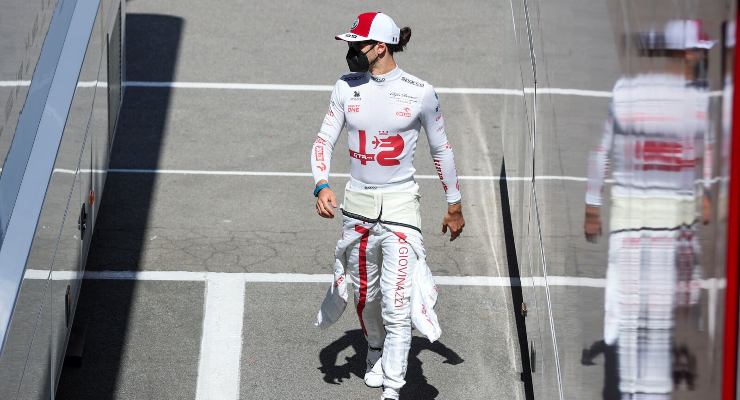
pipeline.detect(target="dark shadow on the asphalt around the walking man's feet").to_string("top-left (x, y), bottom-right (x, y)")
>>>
top-left (319, 329), bottom-right (465, 400)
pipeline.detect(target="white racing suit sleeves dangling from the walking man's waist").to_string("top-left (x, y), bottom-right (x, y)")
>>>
top-left (314, 220), bottom-right (442, 342)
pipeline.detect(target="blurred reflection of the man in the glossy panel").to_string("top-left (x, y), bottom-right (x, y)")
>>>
top-left (584, 21), bottom-right (712, 399)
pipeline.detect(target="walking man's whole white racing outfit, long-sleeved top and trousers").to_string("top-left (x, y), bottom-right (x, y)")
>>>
top-left (310, 67), bottom-right (461, 398)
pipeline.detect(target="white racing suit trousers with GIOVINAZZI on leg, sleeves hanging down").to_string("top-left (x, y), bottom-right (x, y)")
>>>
top-left (316, 182), bottom-right (441, 391)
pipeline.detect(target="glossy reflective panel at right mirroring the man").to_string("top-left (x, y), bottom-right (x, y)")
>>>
top-left (516, 1), bottom-right (735, 399)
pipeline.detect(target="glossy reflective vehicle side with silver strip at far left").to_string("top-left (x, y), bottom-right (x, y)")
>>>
top-left (0, 1), bottom-right (121, 399)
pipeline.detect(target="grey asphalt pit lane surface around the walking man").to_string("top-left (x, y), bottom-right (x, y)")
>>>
top-left (58, 0), bottom-right (523, 399)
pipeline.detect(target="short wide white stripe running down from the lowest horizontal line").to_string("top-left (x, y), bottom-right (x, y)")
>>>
top-left (195, 273), bottom-right (245, 400)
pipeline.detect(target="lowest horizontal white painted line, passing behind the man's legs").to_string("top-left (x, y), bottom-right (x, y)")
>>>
top-left (24, 269), bottom-right (726, 289)
